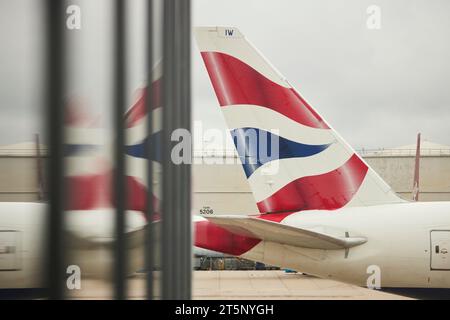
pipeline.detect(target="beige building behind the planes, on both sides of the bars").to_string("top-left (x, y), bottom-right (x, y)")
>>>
top-left (0, 141), bottom-right (450, 214)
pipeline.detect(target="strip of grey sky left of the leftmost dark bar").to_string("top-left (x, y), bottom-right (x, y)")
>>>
top-left (0, 0), bottom-right (43, 144)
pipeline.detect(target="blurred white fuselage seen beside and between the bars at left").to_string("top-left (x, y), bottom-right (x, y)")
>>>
top-left (0, 202), bottom-right (214, 289)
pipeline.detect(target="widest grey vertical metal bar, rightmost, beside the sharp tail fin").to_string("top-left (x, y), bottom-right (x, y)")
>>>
top-left (162, 0), bottom-right (191, 299)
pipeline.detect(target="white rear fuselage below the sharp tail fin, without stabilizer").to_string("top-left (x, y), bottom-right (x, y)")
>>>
top-left (243, 202), bottom-right (450, 288)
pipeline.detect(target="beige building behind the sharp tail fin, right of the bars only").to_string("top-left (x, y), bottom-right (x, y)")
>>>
top-left (192, 141), bottom-right (450, 214)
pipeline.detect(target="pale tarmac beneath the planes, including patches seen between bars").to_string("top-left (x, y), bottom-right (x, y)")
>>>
top-left (69, 270), bottom-right (409, 300)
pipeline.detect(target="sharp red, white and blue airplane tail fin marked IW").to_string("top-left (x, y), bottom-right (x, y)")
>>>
top-left (195, 27), bottom-right (403, 213)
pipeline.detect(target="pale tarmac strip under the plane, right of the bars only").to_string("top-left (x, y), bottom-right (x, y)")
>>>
top-left (193, 270), bottom-right (406, 300)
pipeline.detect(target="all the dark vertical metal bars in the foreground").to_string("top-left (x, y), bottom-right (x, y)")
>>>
top-left (44, 0), bottom-right (192, 299)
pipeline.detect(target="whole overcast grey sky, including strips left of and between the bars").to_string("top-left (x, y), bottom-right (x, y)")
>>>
top-left (0, 0), bottom-right (450, 148)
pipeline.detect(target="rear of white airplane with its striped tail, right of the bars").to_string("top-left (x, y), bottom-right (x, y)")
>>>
top-left (195, 27), bottom-right (450, 296)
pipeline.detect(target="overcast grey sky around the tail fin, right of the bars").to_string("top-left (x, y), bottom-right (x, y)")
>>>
top-left (193, 0), bottom-right (450, 148)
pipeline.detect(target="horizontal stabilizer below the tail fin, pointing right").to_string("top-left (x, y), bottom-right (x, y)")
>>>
top-left (207, 216), bottom-right (367, 250)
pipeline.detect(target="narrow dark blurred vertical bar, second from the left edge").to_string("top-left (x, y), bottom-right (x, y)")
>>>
top-left (113, 0), bottom-right (127, 300)
